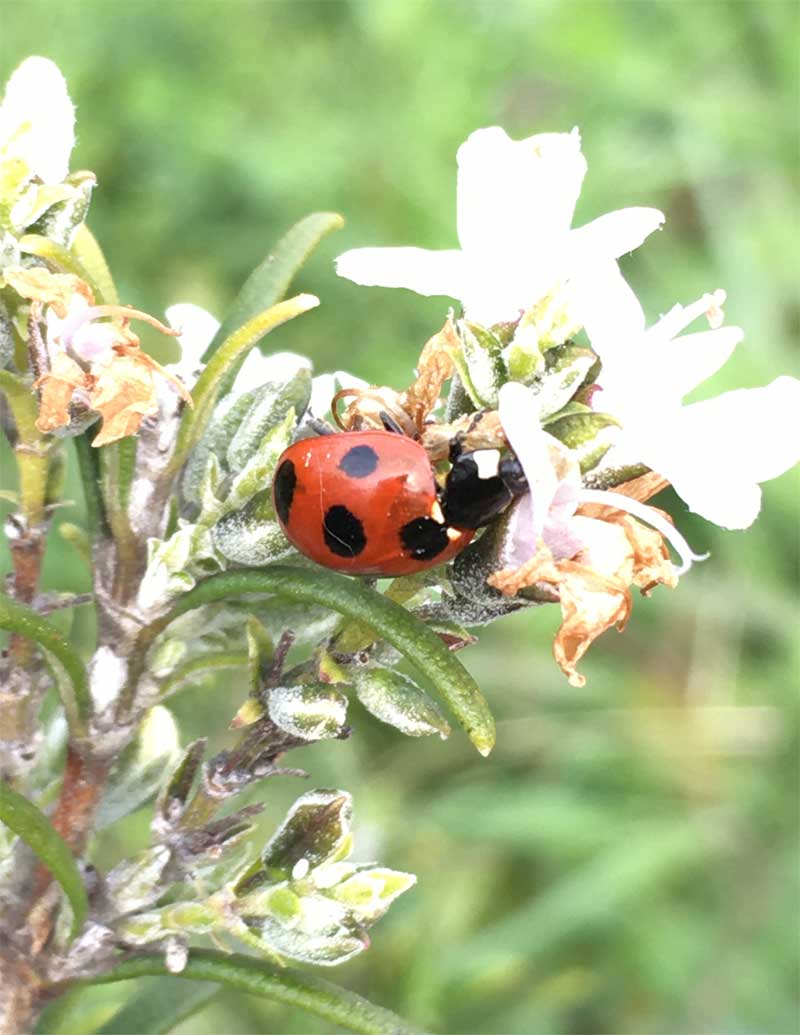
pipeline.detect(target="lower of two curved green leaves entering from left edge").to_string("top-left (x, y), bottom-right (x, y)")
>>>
top-left (0, 780), bottom-right (89, 938)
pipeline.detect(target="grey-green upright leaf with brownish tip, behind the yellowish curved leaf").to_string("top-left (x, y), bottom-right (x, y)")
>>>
top-left (204, 212), bottom-right (345, 361)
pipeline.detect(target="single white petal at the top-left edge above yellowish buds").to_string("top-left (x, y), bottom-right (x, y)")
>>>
top-left (0, 57), bottom-right (75, 183)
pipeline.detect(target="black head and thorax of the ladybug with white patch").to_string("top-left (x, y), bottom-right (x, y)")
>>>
top-left (442, 449), bottom-right (528, 529)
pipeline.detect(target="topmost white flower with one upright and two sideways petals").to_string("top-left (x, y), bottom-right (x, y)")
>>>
top-left (336, 126), bottom-right (663, 326)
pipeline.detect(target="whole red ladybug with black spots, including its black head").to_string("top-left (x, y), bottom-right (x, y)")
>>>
top-left (272, 422), bottom-right (528, 575)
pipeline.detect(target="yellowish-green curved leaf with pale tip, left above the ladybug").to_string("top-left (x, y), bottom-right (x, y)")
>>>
top-left (170, 295), bottom-right (320, 472)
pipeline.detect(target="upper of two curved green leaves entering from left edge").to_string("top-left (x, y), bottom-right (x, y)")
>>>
top-left (0, 593), bottom-right (91, 737)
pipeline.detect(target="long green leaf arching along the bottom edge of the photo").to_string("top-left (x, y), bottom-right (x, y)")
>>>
top-left (91, 949), bottom-right (421, 1035)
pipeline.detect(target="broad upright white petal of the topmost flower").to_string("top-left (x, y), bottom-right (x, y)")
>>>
top-left (457, 126), bottom-right (587, 255)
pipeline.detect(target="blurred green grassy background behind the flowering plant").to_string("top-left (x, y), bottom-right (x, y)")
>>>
top-left (0, 0), bottom-right (800, 1035)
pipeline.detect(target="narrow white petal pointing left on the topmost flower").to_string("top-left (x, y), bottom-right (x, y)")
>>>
top-left (336, 248), bottom-right (466, 299)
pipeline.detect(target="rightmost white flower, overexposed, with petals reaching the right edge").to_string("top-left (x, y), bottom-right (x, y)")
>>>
top-left (580, 263), bottom-right (800, 529)
